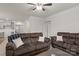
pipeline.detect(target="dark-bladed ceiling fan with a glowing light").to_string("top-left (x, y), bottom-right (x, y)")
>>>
top-left (27, 3), bottom-right (52, 11)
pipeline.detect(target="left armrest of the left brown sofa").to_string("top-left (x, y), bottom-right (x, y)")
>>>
top-left (6, 42), bottom-right (16, 56)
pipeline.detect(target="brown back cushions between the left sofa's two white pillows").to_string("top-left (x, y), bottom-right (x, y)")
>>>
top-left (21, 33), bottom-right (43, 44)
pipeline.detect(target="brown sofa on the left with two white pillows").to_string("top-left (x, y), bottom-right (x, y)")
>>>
top-left (6, 33), bottom-right (51, 56)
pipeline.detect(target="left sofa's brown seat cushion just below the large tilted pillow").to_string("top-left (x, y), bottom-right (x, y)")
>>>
top-left (14, 44), bottom-right (35, 55)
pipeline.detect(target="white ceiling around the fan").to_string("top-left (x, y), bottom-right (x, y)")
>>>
top-left (0, 3), bottom-right (79, 20)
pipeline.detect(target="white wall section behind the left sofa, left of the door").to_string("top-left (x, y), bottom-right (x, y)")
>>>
top-left (24, 16), bottom-right (45, 36)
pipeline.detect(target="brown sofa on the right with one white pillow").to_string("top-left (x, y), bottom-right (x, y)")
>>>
top-left (51, 32), bottom-right (79, 56)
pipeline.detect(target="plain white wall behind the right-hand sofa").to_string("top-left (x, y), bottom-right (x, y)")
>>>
top-left (47, 6), bottom-right (79, 36)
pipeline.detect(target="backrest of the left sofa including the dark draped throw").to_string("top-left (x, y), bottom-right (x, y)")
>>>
top-left (8, 32), bottom-right (43, 44)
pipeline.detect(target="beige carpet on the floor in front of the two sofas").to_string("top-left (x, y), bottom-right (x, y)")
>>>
top-left (37, 47), bottom-right (72, 56)
